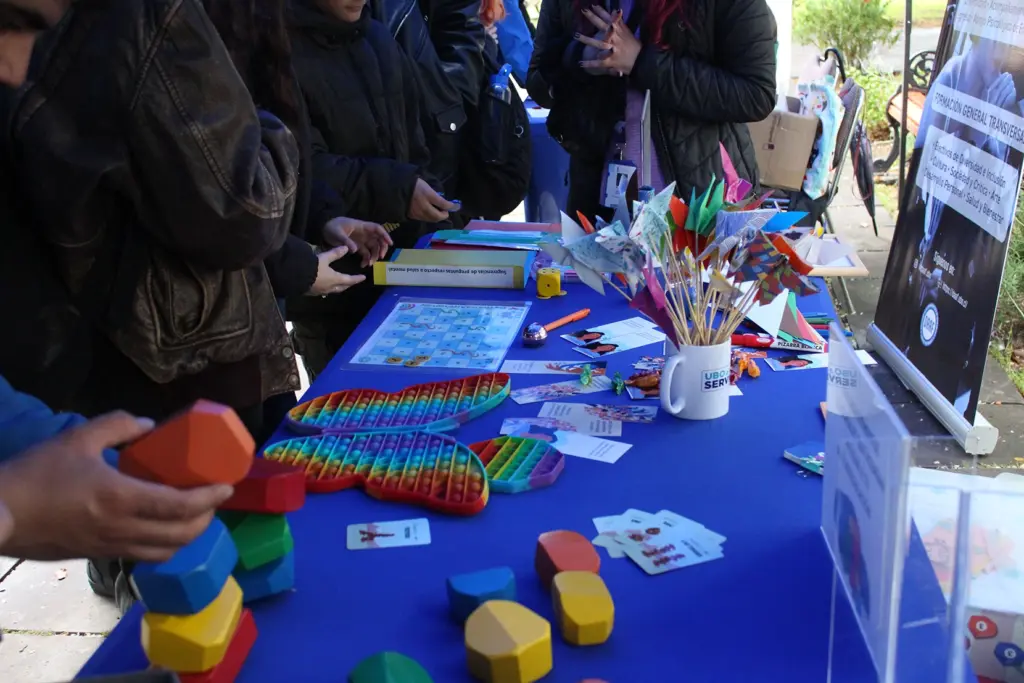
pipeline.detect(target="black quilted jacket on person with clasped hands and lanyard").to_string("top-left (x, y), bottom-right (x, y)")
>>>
top-left (527, 0), bottom-right (776, 209)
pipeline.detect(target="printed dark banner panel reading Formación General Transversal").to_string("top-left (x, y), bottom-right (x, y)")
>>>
top-left (876, 0), bottom-right (1024, 422)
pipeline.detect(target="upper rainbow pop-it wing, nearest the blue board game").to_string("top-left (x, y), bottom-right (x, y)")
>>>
top-left (287, 373), bottom-right (512, 434)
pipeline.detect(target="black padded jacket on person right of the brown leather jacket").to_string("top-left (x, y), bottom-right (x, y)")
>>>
top-left (291, 0), bottom-right (430, 229)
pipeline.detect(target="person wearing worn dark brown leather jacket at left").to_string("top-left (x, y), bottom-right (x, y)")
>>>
top-left (0, 0), bottom-right (298, 596)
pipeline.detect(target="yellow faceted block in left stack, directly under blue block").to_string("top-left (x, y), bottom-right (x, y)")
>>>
top-left (142, 577), bottom-right (242, 674)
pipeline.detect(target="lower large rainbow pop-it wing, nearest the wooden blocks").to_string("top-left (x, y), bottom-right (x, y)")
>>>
top-left (263, 431), bottom-right (488, 515)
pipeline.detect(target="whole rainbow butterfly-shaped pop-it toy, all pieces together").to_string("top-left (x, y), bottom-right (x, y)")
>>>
top-left (263, 373), bottom-right (564, 515)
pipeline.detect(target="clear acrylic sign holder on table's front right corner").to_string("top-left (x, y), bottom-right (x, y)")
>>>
top-left (821, 326), bottom-right (1011, 683)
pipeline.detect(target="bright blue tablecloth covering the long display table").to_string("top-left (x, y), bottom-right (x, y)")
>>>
top-left (82, 278), bottom-right (939, 683)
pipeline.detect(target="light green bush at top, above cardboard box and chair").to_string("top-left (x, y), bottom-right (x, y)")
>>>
top-left (794, 0), bottom-right (899, 69)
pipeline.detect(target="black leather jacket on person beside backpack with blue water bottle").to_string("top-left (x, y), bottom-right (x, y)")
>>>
top-left (369, 0), bottom-right (486, 193)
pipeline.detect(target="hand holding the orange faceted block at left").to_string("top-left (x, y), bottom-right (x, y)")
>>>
top-left (0, 413), bottom-right (233, 562)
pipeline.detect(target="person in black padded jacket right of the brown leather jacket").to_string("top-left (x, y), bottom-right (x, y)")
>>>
top-left (288, 0), bottom-right (459, 379)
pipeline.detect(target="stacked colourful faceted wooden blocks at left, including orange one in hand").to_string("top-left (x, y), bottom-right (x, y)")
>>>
top-left (118, 401), bottom-right (305, 683)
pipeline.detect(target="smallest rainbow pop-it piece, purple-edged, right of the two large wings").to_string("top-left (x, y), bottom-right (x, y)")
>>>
top-left (469, 436), bottom-right (565, 494)
